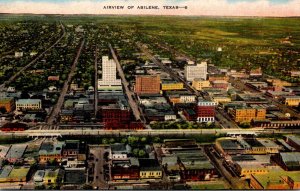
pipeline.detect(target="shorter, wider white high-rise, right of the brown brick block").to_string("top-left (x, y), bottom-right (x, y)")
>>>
top-left (184, 62), bottom-right (207, 82)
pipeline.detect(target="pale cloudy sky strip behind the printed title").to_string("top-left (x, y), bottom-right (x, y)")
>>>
top-left (0, 0), bottom-right (300, 17)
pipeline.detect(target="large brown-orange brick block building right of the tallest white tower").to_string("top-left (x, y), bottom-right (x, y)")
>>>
top-left (135, 75), bottom-right (160, 95)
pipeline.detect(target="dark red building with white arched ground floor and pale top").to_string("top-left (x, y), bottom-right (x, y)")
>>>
top-left (196, 100), bottom-right (217, 122)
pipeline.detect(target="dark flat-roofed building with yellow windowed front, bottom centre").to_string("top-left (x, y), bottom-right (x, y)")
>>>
top-left (139, 159), bottom-right (163, 179)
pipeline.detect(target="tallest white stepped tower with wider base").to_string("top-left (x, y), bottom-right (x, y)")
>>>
top-left (98, 56), bottom-right (122, 89)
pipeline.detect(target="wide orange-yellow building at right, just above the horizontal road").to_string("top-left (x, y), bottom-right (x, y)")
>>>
top-left (229, 107), bottom-right (266, 123)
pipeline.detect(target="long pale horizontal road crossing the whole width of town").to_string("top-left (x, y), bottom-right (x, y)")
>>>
top-left (0, 128), bottom-right (300, 137)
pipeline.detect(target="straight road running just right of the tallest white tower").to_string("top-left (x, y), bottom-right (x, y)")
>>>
top-left (109, 44), bottom-right (145, 123)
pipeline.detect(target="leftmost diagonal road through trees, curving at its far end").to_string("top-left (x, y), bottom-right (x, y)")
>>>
top-left (0, 24), bottom-right (66, 91)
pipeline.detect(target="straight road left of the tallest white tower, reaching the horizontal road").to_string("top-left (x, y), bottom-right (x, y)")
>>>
top-left (47, 39), bottom-right (85, 125)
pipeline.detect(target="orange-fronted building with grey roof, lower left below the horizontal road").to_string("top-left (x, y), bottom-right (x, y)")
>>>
top-left (39, 142), bottom-right (64, 163)
